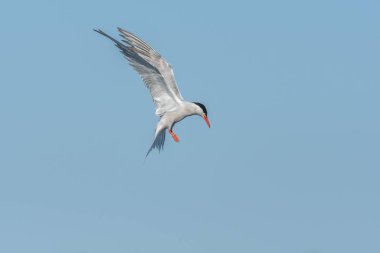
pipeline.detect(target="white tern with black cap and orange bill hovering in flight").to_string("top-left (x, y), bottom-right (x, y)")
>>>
top-left (94, 28), bottom-right (210, 156)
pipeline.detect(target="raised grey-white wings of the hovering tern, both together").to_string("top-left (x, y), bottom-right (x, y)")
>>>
top-left (95, 28), bottom-right (183, 116)
